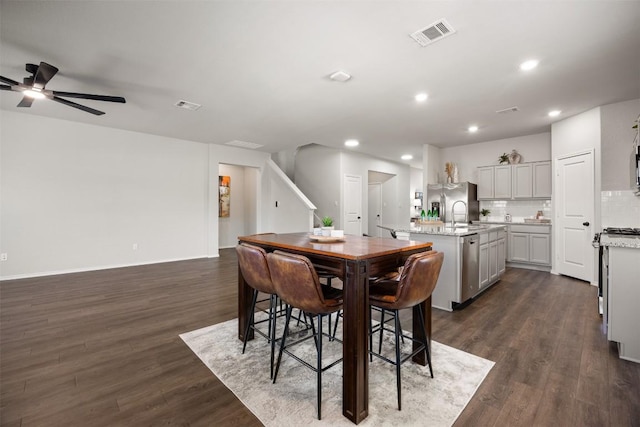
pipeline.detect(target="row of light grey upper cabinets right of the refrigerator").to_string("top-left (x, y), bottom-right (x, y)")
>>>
top-left (478, 161), bottom-right (551, 200)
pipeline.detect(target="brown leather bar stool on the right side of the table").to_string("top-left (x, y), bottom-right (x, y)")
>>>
top-left (369, 251), bottom-right (444, 410)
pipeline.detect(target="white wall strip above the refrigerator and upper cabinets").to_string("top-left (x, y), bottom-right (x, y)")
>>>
top-left (440, 132), bottom-right (551, 183)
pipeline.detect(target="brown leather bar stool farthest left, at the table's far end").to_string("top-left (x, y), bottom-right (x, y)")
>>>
top-left (236, 243), bottom-right (277, 378)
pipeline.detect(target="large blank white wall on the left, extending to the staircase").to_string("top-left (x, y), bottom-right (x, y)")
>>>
top-left (0, 110), bottom-right (309, 280)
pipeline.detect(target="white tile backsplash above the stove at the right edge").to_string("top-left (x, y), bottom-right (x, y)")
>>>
top-left (600, 190), bottom-right (640, 228)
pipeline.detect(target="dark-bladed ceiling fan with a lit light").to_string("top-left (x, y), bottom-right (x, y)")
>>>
top-left (0, 62), bottom-right (126, 116)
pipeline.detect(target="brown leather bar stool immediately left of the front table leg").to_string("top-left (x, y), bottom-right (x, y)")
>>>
top-left (267, 251), bottom-right (342, 419)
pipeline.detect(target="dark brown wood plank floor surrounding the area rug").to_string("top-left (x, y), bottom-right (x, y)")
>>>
top-left (0, 249), bottom-right (640, 426)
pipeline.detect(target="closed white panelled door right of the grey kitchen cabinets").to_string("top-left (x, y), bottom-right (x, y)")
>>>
top-left (554, 152), bottom-right (595, 282)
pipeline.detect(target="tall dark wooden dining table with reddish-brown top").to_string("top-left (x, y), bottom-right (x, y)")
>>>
top-left (238, 233), bottom-right (432, 424)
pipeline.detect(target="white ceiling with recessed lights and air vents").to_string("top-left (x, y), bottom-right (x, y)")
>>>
top-left (0, 0), bottom-right (640, 166)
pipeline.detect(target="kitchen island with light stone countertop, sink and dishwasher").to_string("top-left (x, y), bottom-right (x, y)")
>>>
top-left (379, 223), bottom-right (506, 311)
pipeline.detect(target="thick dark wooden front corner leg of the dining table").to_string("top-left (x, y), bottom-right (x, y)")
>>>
top-left (342, 261), bottom-right (369, 424)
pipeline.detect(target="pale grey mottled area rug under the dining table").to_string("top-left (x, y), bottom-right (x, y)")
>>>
top-left (180, 319), bottom-right (494, 426)
